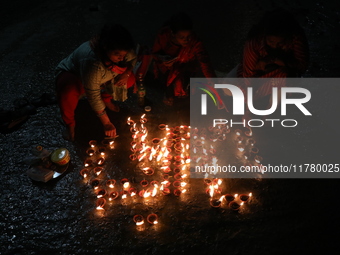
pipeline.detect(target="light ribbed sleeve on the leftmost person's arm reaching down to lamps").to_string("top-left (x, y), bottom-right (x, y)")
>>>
top-left (82, 62), bottom-right (105, 111)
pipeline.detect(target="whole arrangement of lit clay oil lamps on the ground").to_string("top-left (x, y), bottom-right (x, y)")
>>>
top-left (80, 114), bottom-right (262, 227)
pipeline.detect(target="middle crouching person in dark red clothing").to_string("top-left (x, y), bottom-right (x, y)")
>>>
top-left (152, 13), bottom-right (216, 105)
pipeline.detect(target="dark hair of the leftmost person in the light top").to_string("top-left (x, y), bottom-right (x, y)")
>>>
top-left (90, 23), bottom-right (135, 58)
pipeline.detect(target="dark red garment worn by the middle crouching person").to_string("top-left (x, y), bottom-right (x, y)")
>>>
top-left (152, 27), bottom-right (216, 96)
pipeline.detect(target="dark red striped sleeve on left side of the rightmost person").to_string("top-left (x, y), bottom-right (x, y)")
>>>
top-left (242, 39), bottom-right (260, 77)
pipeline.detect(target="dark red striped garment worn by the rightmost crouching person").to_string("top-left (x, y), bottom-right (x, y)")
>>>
top-left (238, 33), bottom-right (308, 98)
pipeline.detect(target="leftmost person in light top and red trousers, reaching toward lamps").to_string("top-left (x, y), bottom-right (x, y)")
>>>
top-left (56, 23), bottom-right (136, 141)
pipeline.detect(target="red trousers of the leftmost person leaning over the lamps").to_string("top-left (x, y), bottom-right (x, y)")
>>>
top-left (56, 71), bottom-right (135, 126)
